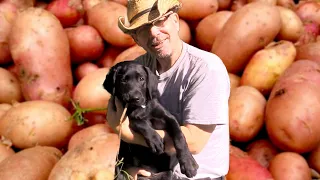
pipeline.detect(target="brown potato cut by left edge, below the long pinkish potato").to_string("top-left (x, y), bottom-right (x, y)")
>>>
top-left (0, 67), bottom-right (23, 104)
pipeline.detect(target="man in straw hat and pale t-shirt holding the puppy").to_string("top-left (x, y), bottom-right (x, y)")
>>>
top-left (107, 0), bottom-right (230, 180)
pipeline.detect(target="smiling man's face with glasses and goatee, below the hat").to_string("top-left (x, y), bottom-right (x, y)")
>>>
top-left (132, 11), bottom-right (179, 59)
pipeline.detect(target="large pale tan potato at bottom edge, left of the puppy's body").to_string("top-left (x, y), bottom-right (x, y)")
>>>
top-left (48, 133), bottom-right (119, 180)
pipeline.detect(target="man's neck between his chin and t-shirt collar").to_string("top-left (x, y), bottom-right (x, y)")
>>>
top-left (157, 40), bottom-right (183, 74)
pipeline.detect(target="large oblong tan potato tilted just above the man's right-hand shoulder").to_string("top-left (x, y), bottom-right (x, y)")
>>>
top-left (211, 2), bottom-right (281, 74)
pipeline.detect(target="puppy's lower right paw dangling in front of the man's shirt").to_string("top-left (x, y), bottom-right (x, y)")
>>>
top-left (179, 153), bottom-right (199, 178)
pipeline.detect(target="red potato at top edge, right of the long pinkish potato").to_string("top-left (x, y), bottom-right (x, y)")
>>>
top-left (46, 0), bottom-right (84, 27)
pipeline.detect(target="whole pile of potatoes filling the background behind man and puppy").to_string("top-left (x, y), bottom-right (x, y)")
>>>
top-left (0, 0), bottom-right (320, 180)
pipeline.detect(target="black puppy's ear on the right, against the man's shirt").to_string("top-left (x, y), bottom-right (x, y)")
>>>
top-left (143, 66), bottom-right (159, 99)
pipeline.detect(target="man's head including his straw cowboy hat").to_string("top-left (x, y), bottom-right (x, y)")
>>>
top-left (118, 0), bottom-right (181, 58)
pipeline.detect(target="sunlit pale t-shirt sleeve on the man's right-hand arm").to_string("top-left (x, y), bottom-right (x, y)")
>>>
top-left (182, 63), bottom-right (230, 124)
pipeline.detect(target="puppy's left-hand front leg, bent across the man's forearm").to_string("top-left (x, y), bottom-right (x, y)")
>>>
top-left (130, 119), bottom-right (164, 154)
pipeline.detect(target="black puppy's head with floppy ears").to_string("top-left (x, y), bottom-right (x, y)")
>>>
top-left (103, 61), bottom-right (158, 106)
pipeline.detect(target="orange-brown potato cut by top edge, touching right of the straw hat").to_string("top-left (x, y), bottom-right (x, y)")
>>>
top-left (178, 0), bottom-right (219, 20)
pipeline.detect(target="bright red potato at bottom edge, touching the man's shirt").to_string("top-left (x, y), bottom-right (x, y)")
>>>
top-left (226, 145), bottom-right (273, 180)
